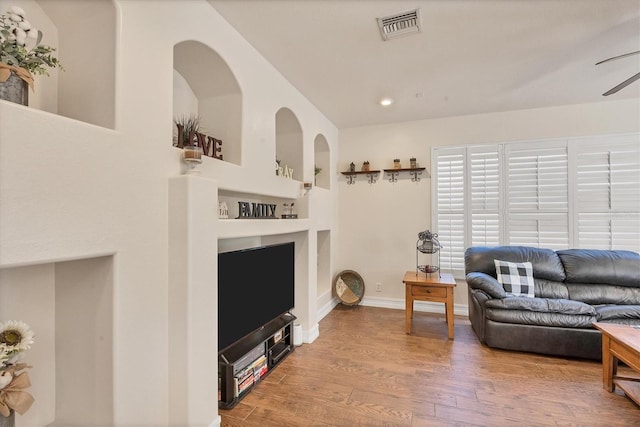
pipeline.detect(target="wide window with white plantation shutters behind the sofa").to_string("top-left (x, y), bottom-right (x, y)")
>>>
top-left (432, 134), bottom-right (640, 276)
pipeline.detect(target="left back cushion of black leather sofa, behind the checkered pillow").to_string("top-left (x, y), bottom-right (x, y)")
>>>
top-left (464, 246), bottom-right (565, 282)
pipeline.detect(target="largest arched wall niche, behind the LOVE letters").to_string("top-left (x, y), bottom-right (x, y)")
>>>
top-left (173, 40), bottom-right (242, 165)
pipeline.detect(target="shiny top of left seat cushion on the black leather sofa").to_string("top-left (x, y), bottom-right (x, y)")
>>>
top-left (485, 297), bottom-right (598, 316)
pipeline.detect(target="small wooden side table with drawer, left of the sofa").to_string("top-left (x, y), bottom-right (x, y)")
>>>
top-left (402, 271), bottom-right (456, 340)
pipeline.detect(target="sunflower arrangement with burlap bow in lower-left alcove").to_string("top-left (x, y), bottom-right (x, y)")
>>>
top-left (0, 320), bottom-right (34, 425)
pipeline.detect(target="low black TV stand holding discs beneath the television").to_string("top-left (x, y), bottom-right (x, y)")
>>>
top-left (218, 313), bottom-right (296, 409)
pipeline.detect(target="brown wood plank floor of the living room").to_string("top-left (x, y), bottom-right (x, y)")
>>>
top-left (220, 305), bottom-right (640, 427)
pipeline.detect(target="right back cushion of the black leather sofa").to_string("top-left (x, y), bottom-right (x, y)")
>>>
top-left (557, 249), bottom-right (640, 288)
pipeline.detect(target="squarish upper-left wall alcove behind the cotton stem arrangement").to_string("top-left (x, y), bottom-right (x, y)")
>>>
top-left (15, 0), bottom-right (117, 129)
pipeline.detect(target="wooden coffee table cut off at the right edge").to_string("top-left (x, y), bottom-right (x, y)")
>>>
top-left (593, 323), bottom-right (640, 405)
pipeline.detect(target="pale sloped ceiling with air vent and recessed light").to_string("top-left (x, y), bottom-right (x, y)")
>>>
top-left (209, 0), bottom-right (640, 128)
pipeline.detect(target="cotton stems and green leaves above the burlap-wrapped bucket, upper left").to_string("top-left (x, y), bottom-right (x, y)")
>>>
top-left (0, 6), bottom-right (64, 76)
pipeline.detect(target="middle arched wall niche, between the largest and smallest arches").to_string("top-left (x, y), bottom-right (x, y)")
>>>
top-left (276, 107), bottom-right (303, 181)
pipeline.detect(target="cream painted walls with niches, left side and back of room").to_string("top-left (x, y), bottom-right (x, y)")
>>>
top-left (0, 0), bottom-right (640, 426)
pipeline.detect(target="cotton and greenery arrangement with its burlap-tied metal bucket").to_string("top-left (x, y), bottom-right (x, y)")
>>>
top-left (0, 6), bottom-right (63, 105)
